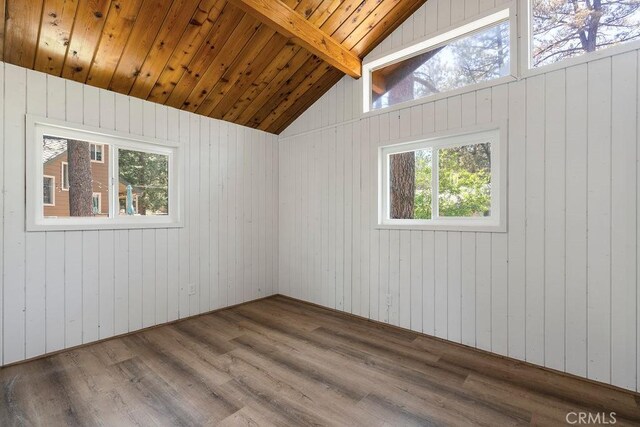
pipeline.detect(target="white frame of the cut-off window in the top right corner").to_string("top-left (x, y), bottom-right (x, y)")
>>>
top-left (519, 0), bottom-right (640, 78)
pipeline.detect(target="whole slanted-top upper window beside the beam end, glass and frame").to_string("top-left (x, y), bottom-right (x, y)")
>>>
top-left (363, 9), bottom-right (516, 112)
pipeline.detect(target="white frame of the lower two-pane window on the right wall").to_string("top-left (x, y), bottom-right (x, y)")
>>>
top-left (377, 125), bottom-right (507, 232)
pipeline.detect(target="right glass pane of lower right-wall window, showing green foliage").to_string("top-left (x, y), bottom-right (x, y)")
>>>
top-left (438, 143), bottom-right (491, 217)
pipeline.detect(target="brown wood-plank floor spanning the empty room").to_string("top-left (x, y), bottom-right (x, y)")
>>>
top-left (0, 296), bottom-right (640, 426)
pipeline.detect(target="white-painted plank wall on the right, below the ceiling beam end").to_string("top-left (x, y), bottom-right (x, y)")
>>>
top-left (279, 0), bottom-right (640, 390)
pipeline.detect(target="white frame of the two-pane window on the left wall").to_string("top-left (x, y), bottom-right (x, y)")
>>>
top-left (26, 115), bottom-right (184, 231)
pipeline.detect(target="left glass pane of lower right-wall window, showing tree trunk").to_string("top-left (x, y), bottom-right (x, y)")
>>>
top-left (389, 149), bottom-right (431, 219)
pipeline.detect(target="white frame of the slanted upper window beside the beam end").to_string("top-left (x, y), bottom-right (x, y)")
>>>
top-left (362, 1), bottom-right (518, 116)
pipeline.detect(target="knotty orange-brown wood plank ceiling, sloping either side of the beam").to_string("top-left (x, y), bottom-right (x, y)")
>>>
top-left (5, 0), bottom-right (426, 133)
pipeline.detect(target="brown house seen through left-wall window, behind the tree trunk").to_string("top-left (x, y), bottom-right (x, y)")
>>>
top-left (42, 138), bottom-right (111, 217)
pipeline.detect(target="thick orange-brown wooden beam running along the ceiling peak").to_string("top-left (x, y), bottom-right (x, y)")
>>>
top-left (232, 0), bottom-right (362, 78)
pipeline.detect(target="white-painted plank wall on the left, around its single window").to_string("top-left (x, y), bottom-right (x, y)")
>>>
top-left (0, 63), bottom-right (278, 365)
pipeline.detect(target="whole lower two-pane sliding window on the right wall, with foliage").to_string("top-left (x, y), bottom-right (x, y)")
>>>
top-left (379, 130), bottom-right (504, 231)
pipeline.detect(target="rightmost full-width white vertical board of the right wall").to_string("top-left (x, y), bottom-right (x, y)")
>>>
top-left (611, 52), bottom-right (638, 389)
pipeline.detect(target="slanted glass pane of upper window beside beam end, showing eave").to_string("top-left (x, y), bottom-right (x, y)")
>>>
top-left (371, 21), bottom-right (510, 110)
